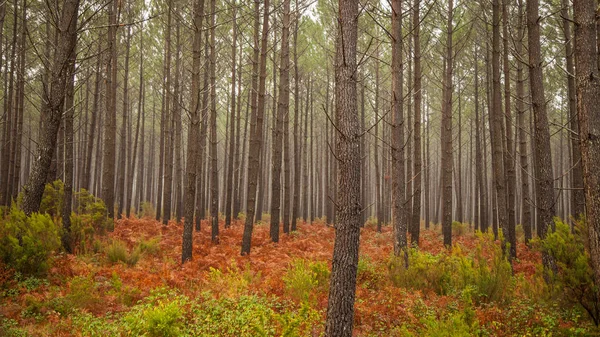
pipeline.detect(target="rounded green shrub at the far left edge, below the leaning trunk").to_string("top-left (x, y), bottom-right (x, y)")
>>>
top-left (0, 206), bottom-right (61, 274)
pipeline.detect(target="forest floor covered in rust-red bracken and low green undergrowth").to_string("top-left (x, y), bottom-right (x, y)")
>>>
top-left (0, 214), bottom-right (600, 336)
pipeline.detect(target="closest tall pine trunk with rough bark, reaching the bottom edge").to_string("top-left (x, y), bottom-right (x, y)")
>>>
top-left (325, 0), bottom-right (360, 337)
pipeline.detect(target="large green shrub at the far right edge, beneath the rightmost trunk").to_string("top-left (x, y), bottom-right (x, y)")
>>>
top-left (537, 219), bottom-right (600, 326)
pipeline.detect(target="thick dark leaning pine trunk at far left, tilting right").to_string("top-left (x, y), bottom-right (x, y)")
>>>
top-left (23, 0), bottom-right (79, 215)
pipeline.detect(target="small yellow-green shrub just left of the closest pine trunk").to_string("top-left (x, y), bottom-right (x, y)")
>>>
top-left (283, 259), bottom-right (330, 301)
